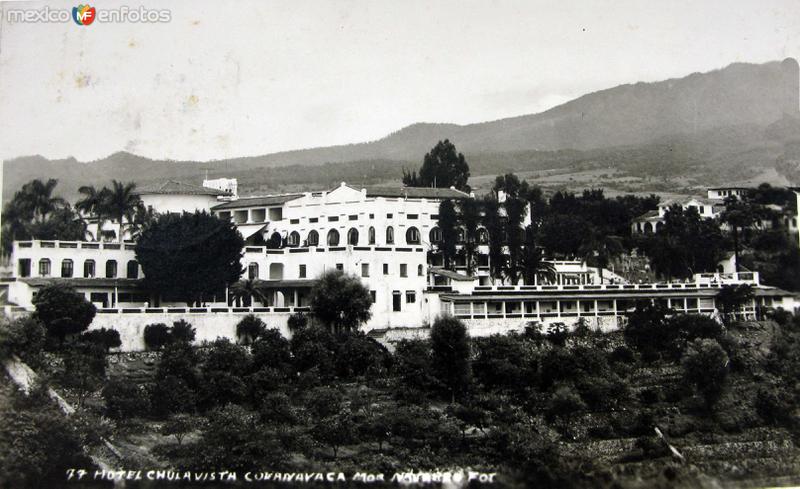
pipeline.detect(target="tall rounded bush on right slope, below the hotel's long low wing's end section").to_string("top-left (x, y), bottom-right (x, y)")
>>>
top-left (681, 339), bottom-right (729, 409)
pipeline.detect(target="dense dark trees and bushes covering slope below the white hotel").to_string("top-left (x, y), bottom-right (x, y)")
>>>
top-left (0, 304), bottom-right (800, 487)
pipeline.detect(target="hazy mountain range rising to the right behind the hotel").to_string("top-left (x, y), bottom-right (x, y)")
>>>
top-left (3, 58), bottom-right (800, 199)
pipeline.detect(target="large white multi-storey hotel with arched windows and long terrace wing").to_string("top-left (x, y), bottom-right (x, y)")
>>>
top-left (0, 182), bottom-right (795, 349)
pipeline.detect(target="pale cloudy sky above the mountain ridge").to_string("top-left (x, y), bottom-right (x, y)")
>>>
top-left (0, 0), bottom-right (800, 161)
